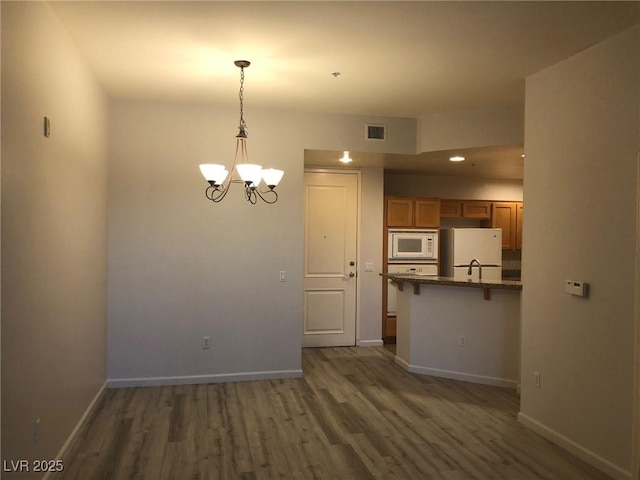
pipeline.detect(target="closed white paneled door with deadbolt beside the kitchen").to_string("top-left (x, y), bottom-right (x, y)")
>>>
top-left (302, 172), bottom-right (358, 347)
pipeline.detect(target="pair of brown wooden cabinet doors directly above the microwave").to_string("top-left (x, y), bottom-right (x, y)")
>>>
top-left (385, 197), bottom-right (440, 228)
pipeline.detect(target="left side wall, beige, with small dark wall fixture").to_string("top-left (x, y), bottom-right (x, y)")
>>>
top-left (1, 2), bottom-right (108, 479)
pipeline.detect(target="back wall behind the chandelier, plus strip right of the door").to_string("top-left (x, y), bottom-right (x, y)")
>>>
top-left (108, 101), bottom-right (406, 385)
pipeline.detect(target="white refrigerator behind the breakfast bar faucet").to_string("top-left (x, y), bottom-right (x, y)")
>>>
top-left (440, 228), bottom-right (502, 281)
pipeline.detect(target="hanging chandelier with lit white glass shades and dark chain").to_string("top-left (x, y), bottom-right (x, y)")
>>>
top-left (200, 60), bottom-right (284, 205)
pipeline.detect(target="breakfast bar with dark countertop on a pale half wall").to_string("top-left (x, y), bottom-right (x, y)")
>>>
top-left (382, 274), bottom-right (522, 388)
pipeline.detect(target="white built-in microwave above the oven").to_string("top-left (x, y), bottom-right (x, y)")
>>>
top-left (387, 230), bottom-right (438, 263)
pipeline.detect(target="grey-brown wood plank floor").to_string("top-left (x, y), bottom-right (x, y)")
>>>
top-left (51, 347), bottom-right (609, 480)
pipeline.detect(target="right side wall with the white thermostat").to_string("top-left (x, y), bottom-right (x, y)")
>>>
top-left (520, 26), bottom-right (640, 478)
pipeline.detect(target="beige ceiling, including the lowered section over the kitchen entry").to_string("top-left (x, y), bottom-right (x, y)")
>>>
top-left (49, 0), bottom-right (640, 178)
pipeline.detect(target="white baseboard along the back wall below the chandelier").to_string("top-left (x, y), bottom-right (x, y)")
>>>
top-left (107, 370), bottom-right (302, 388)
